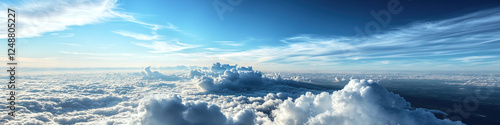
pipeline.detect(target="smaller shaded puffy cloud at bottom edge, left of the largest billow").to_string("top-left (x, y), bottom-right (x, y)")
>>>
top-left (141, 95), bottom-right (256, 125)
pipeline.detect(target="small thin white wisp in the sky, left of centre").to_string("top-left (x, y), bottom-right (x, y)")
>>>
top-left (133, 40), bottom-right (198, 53)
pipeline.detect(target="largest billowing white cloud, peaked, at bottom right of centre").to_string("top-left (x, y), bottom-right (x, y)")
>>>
top-left (272, 79), bottom-right (463, 125)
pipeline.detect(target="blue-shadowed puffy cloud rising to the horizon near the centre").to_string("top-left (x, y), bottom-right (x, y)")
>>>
top-left (190, 63), bottom-right (317, 91)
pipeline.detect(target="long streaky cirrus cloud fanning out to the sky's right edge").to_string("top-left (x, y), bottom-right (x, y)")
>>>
top-left (214, 8), bottom-right (500, 64)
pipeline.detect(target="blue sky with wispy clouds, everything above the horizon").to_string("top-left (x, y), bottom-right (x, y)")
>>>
top-left (0, 0), bottom-right (500, 71)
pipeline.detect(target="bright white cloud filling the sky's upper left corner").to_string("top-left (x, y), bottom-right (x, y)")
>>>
top-left (0, 0), bottom-right (181, 38)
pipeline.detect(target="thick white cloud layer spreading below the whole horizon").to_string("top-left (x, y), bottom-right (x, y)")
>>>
top-left (0, 63), bottom-right (488, 125)
